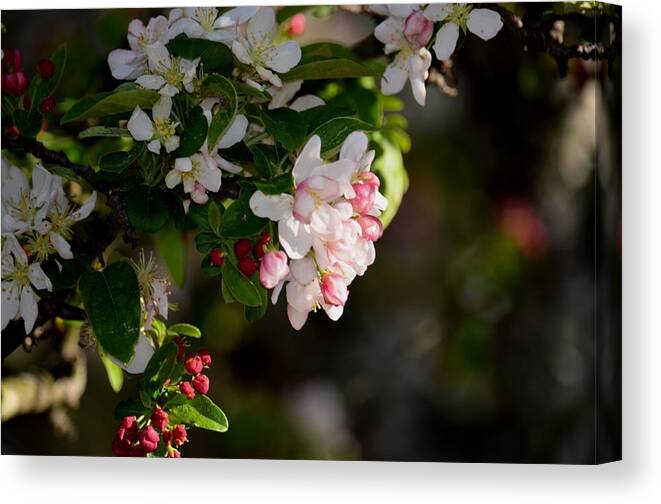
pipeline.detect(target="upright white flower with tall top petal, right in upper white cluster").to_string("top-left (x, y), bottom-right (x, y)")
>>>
top-left (232, 7), bottom-right (301, 86)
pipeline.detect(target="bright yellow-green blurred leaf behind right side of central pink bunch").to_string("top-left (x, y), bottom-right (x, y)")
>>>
top-left (372, 134), bottom-right (409, 228)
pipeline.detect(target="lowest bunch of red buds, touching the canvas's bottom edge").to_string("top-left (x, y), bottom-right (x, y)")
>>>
top-left (112, 412), bottom-right (188, 458)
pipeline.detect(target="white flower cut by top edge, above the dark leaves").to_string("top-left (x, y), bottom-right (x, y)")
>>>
top-left (168, 7), bottom-right (259, 43)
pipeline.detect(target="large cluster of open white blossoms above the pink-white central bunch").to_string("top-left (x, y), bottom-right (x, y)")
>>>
top-left (108, 7), bottom-right (302, 210)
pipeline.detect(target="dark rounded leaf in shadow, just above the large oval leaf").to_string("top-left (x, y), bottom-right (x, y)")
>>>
top-left (126, 185), bottom-right (169, 233)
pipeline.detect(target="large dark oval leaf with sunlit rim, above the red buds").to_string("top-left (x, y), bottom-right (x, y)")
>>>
top-left (78, 261), bottom-right (140, 362)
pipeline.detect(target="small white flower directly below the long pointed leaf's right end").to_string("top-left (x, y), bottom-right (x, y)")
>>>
top-left (127, 96), bottom-right (179, 154)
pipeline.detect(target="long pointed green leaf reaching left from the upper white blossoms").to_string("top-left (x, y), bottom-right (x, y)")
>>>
top-left (60, 88), bottom-right (160, 124)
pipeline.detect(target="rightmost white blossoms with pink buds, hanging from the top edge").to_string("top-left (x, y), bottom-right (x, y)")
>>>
top-left (371, 3), bottom-right (503, 105)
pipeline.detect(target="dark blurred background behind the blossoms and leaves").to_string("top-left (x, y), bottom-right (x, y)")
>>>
top-left (2, 4), bottom-right (621, 463)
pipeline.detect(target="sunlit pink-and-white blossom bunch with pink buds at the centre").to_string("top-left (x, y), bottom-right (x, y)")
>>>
top-left (250, 132), bottom-right (387, 329)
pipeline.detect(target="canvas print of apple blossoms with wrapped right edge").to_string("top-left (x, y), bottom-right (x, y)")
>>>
top-left (0, 2), bottom-right (622, 464)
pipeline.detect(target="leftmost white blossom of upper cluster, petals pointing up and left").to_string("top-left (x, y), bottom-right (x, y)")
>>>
top-left (108, 16), bottom-right (169, 80)
